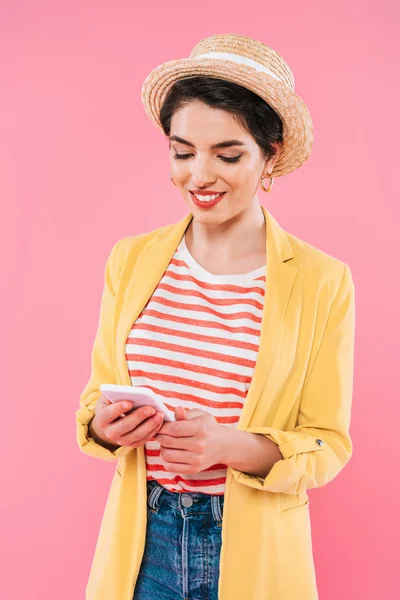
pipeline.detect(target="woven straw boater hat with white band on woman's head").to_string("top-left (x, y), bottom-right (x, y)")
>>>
top-left (142, 33), bottom-right (313, 177)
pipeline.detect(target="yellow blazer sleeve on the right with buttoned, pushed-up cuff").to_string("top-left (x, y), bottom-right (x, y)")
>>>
top-left (232, 264), bottom-right (355, 494)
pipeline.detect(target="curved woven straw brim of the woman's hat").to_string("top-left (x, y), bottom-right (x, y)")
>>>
top-left (141, 58), bottom-right (314, 177)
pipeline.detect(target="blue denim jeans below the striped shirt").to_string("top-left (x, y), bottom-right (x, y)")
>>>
top-left (133, 481), bottom-right (224, 600)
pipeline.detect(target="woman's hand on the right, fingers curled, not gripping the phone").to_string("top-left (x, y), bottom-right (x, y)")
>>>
top-left (154, 406), bottom-right (229, 474)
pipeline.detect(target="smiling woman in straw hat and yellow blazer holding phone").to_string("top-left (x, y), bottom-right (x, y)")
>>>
top-left (76, 34), bottom-right (355, 600)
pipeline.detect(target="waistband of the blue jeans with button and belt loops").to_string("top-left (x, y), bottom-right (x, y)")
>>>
top-left (147, 480), bottom-right (224, 523)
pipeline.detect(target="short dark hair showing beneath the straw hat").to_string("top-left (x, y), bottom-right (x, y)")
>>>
top-left (160, 77), bottom-right (283, 158)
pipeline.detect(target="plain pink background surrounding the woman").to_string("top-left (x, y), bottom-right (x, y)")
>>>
top-left (0, 0), bottom-right (400, 600)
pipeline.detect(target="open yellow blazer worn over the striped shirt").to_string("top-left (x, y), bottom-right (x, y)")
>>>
top-left (76, 206), bottom-right (355, 600)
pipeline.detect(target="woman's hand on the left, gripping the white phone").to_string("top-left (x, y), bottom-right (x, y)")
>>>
top-left (91, 395), bottom-right (164, 448)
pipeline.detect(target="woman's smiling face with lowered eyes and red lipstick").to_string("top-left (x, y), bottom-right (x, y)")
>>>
top-left (169, 100), bottom-right (278, 224)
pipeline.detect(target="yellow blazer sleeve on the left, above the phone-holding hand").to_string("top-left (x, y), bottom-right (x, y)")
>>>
top-left (75, 240), bottom-right (132, 461)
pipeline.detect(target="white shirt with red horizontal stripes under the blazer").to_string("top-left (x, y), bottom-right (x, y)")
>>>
top-left (125, 236), bottom-right (266, 495)
